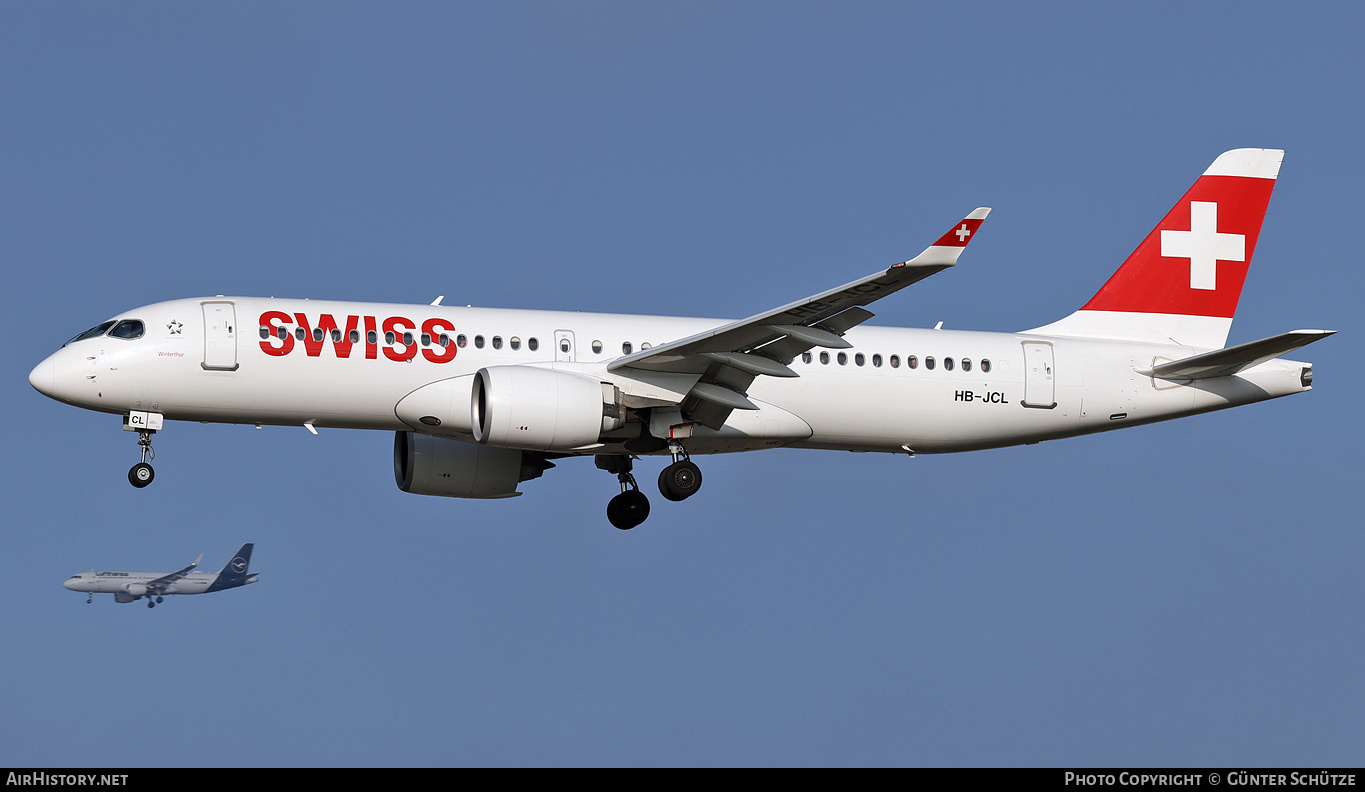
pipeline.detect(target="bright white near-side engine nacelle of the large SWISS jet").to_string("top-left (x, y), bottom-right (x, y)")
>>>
top-left (470, 366), bottom-right (625, 451)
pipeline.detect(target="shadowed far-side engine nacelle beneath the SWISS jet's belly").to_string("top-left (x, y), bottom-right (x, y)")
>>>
top-left (393, 432), bottom-right (554, 498)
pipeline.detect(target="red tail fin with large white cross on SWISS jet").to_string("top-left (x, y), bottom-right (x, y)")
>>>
top-left (1031, 149), bottom-right (1284, 348)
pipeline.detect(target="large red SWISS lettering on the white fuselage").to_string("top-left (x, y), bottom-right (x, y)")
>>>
top-left (261, 311), bottom-right (459, 363)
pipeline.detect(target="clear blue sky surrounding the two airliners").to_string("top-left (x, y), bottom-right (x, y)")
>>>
top-left (0, 3), bottom-right (1365, 767)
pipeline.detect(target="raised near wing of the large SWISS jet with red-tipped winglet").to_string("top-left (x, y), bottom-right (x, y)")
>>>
top-left (607, 206), bottom-right (991, 429)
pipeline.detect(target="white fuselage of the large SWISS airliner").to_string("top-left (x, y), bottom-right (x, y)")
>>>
top-left (30, 298), bottom-right (1309, 453)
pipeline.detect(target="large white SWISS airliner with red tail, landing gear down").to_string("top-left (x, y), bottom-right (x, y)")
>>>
top-left (29, 149), bottom-right (1331, 528)
